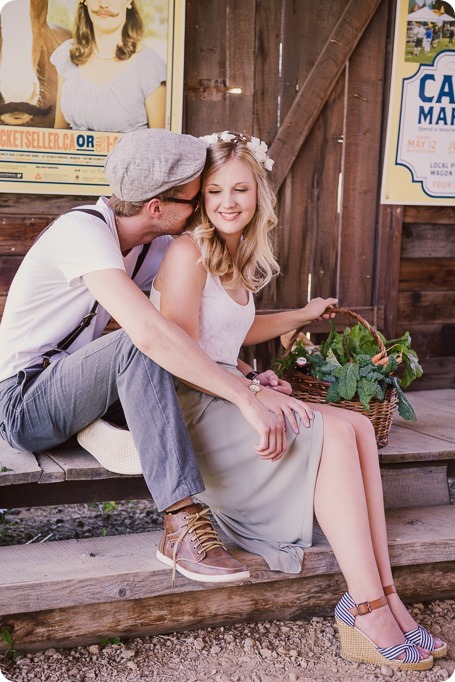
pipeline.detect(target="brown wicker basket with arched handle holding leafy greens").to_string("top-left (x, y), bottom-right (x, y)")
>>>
top-left (283, 308), bottom-right (398, 448)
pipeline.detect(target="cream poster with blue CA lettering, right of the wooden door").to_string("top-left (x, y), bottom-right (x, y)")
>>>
top-left (381, 0), bottom-right (455, 206)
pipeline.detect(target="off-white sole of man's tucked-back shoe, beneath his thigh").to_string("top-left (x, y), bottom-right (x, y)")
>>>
top-left (77, 419), bottom-right (142, 476)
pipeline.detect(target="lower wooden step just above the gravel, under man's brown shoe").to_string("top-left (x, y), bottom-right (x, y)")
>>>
top-left (0, 505), bottom-right (455, 650)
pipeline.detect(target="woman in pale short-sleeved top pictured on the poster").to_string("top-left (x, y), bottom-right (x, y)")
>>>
top-left (51, 0), bottom-right (166, 133)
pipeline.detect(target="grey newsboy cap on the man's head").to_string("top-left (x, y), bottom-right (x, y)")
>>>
top-left (104, 128), bottom-right (207, 201)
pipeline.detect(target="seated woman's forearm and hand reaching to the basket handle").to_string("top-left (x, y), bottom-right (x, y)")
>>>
top-left (244, 298), bottom-right (338, 346)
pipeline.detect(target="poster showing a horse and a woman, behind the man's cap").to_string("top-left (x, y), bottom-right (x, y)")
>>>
top-left (0, 0), bottom-right (185, 196)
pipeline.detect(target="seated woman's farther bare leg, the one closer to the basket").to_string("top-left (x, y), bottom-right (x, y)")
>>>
top-left (313, 405), bottom-right (442, 647)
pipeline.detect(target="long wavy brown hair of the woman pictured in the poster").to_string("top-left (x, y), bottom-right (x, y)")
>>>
top-left (70, 0), bottom-right (144, 66)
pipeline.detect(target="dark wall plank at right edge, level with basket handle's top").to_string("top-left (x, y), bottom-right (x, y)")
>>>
top-left (398, 291), bottom-right (455, 327)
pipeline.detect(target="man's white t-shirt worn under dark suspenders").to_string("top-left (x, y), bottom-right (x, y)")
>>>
top-left (0, 197), bottom-right (172, 381)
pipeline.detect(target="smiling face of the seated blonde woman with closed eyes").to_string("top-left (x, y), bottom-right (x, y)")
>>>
top-left (203, 158), bottom-right (257, 238)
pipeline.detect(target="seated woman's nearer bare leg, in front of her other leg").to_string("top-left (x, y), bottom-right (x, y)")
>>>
top-left (314, 412), bottom-right (424, 647)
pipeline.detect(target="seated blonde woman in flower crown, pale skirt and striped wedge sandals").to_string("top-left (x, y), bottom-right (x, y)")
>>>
top-left (151, 132), bottom-right (447, 670)
